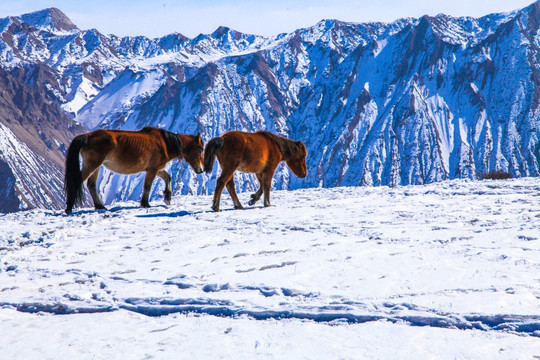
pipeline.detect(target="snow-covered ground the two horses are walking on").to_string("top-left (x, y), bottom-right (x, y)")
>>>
top-left (0, 178), bottom-right (540, 359)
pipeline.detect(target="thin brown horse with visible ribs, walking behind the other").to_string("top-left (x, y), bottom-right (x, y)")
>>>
top-left (64, 127), bottom-right (204, 214)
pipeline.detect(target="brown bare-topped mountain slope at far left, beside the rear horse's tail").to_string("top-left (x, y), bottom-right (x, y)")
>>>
top-left (0, 66), bottom-right (84, 212)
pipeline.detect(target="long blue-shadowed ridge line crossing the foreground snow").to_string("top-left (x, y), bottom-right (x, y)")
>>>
top-left (0, 298), bottom-right (540, 337)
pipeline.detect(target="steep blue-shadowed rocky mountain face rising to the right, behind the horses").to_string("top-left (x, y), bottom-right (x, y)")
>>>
top-left (77, 3), bottom-right (540, 200)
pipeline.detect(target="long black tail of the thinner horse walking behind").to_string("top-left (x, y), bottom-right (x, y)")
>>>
top-left (64, 135), bottom-right (88, 214)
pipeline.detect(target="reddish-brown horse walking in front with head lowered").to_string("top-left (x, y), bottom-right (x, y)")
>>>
top-left (204, 131), bottom-right (307, 211)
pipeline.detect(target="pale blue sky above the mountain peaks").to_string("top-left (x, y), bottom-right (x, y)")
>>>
top-left (0, 0), bottom-right (534, 37)
